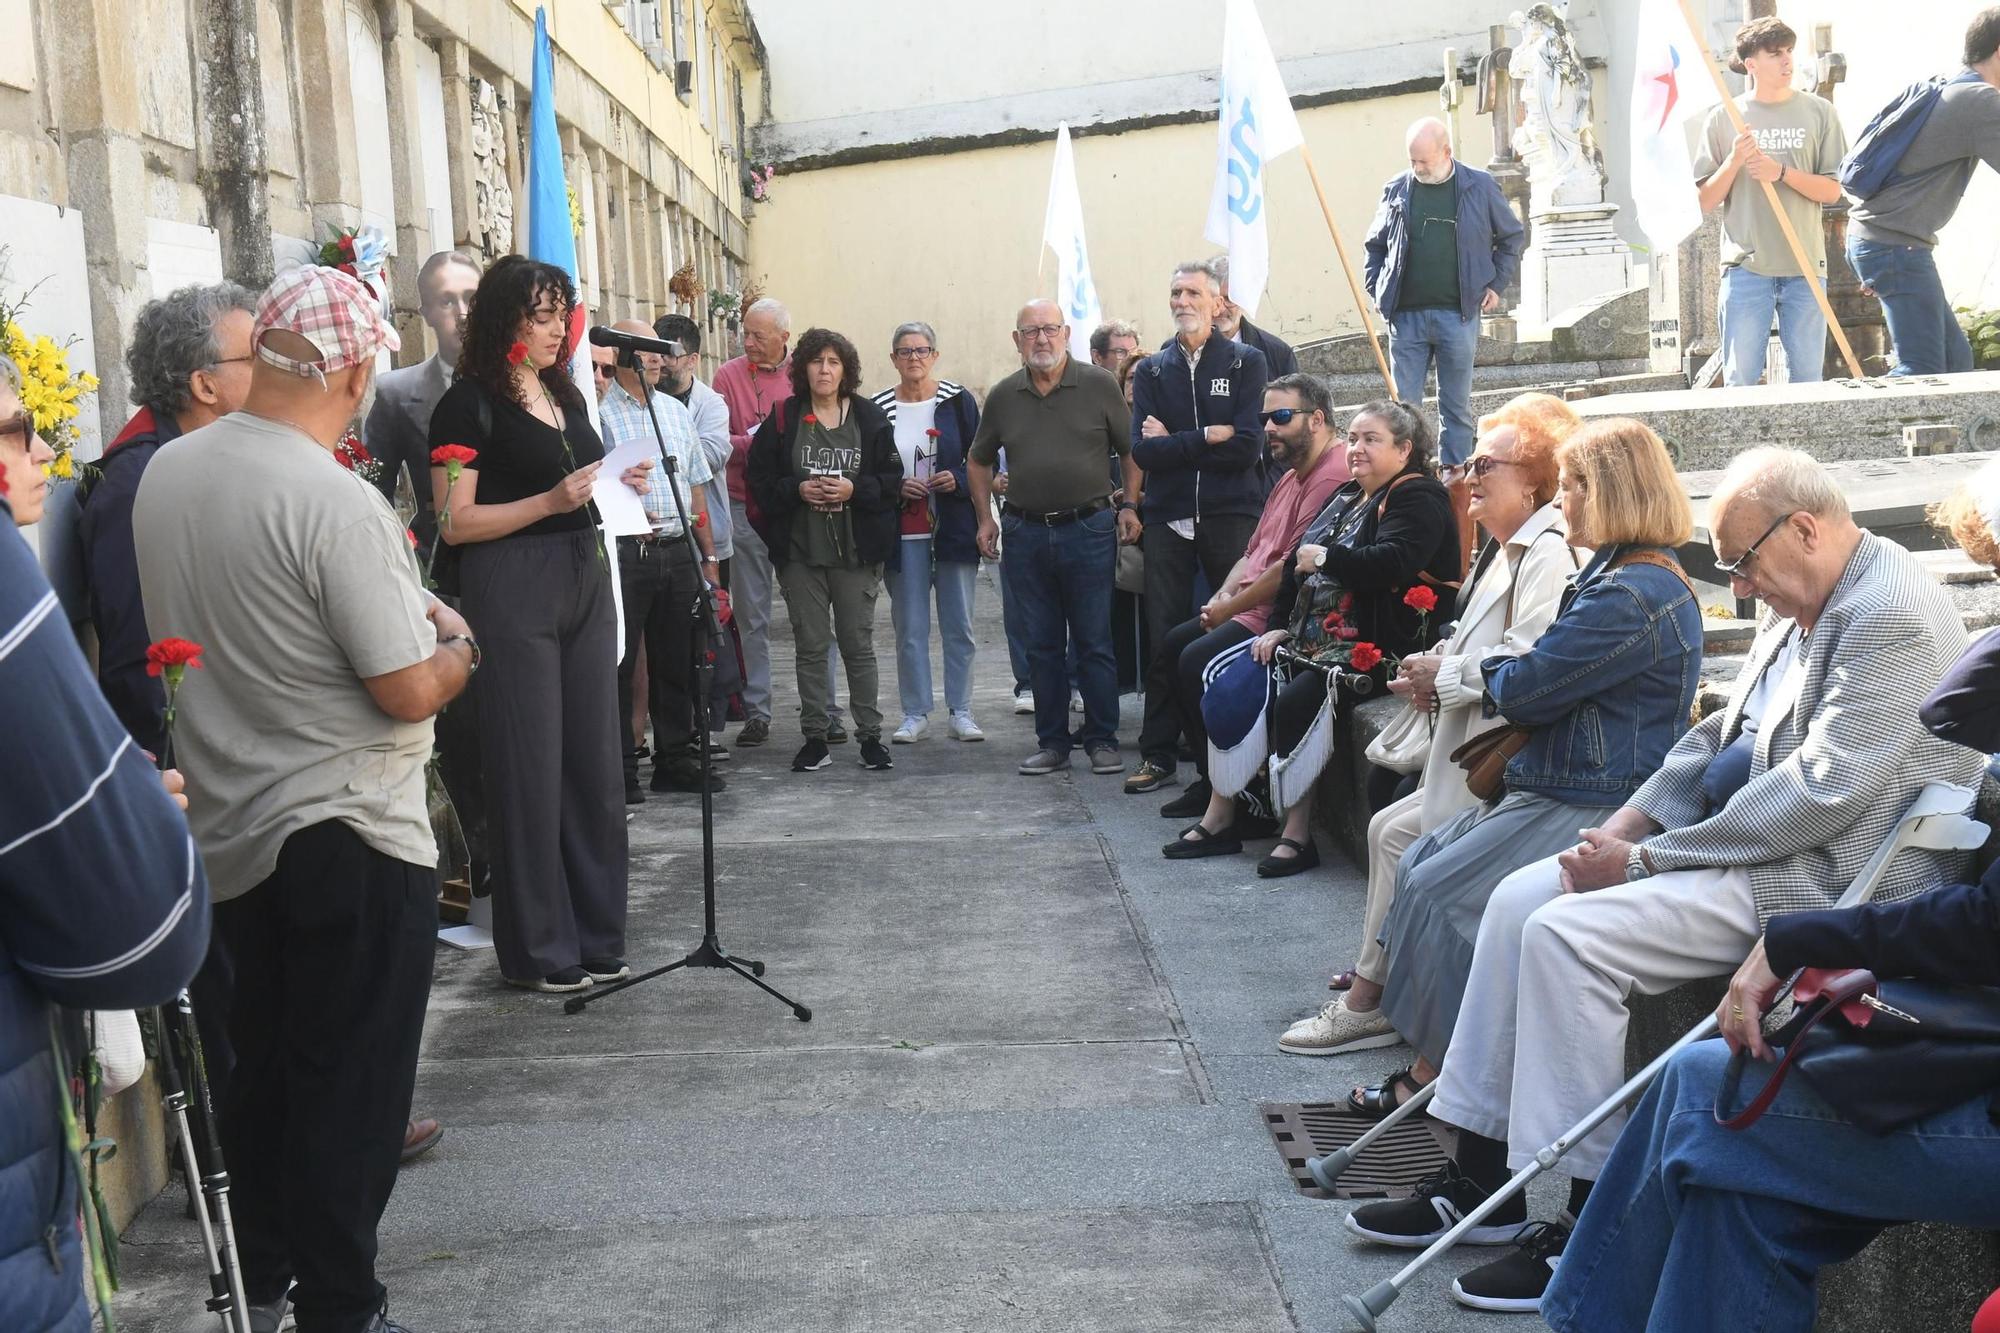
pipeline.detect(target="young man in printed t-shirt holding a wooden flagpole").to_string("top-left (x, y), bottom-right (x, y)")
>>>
top-left (1694, 18), bottom-right (1848, 386)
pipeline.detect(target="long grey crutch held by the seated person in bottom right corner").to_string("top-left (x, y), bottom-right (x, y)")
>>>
top-left (1340, 783), bottom-right (1988, 1333)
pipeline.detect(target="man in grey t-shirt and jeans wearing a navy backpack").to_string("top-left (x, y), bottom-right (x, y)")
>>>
top-left (1848, 6), bottom-right (2000, 374)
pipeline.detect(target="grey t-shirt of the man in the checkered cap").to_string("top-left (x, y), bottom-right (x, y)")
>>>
top-left (132, 412), bottom-right (438, 901)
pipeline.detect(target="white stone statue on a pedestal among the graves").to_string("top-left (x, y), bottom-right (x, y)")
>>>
top-left (1508, 0), bottom-right (1604, 214)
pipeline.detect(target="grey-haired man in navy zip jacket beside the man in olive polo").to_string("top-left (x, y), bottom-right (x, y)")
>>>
top-left (1126, 262), bottom-right (1270, 795)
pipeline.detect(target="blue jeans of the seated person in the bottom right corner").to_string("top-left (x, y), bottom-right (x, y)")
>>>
top-left (1542, 1041), bottom-right (2000, 1333)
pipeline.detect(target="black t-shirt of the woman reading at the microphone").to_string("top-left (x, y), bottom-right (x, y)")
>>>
top-left (430, 378), bottom-right (604, 540)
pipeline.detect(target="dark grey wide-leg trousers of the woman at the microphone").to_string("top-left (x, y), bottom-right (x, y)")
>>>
top-left (464, 532), bottom-right (626, 981)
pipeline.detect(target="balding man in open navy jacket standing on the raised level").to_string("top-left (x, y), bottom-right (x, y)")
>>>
top-left (1366, 118), bottom-right (1526, 468)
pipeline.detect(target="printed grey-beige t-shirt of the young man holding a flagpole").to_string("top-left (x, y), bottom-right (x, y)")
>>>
top-left (1694, 90), bottom-right (1848, 278)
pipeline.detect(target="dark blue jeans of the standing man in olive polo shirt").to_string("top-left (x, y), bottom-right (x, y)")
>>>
top-left (1000, 508), bottom-right (1118, 755)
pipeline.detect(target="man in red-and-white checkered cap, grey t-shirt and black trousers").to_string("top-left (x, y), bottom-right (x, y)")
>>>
top-left (132, 266), bottom-right (478, 1333)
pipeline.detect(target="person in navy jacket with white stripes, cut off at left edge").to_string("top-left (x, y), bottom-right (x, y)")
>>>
top-left (0, 490), bottom-right (208, 1333)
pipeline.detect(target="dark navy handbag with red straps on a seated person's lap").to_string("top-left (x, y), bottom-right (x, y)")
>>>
top-left (1716, 967), bottom-right (2000, 1135)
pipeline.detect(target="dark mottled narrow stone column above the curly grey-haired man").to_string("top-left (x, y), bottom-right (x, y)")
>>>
top-left (192, 0), bottom-right (272, 290)
